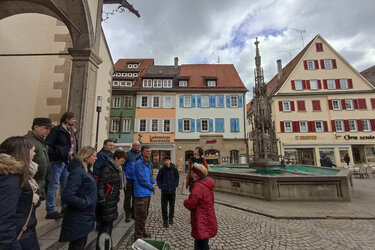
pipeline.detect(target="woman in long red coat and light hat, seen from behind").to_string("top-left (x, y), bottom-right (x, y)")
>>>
top-left (184, 163), bottom-right (217, 250)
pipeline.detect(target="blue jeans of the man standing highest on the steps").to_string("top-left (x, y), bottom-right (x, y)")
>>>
top-left (46, 161), bottom-right (69, 214)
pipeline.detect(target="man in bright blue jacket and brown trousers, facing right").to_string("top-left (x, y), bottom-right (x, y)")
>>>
top-left (134, 145), bottom-right (156, 241)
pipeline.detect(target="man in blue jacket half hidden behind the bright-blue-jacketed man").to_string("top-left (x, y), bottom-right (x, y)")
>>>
top-left (122, 141), bottom-right (141, 222)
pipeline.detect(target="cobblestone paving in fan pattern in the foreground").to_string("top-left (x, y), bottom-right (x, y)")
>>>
top-left (119, 190), bottom-right (375, 250)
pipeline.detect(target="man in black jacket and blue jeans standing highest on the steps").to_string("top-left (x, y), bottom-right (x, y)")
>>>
top-left (46, 112), bottom-right (78, 220)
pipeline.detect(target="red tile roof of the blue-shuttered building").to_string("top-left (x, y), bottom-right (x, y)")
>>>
top-left (178, 64), bottom-right (248, 92)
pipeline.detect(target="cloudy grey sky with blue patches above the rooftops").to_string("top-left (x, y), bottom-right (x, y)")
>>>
top-left (103, 0), bottom-right (375, 102)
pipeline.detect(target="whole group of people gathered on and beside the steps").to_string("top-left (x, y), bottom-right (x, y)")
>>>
top-left (0, 112), bottom-right (217, 250)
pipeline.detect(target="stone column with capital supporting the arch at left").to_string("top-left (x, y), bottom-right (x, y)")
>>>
top-left (68, 48), bottom-right (102, 147)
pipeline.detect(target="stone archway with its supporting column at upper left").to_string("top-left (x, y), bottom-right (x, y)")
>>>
top-left (0, 0), bottom-right (103, 145)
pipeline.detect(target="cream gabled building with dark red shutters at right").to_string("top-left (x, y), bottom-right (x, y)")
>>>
top-left (267, 35), bottom-right (375, 166)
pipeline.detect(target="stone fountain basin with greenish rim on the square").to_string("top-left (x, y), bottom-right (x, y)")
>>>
top-left (209, 165), bottom-right (351, 201)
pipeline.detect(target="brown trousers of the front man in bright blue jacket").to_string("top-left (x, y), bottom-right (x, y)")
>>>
top-left (134, 196), bottom-right (151, 241)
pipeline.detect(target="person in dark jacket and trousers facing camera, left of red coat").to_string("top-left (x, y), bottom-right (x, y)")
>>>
top-left (156, 156), bottom-right (180, 227)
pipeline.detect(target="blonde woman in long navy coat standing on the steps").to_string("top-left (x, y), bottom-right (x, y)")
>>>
top-left (59, 146), bottom-right (97, 250)
